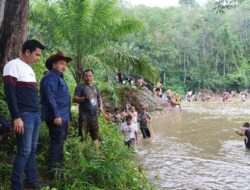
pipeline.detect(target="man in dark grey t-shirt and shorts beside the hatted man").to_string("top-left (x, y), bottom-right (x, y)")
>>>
top-left (73, 69), bottom-right (102, 148)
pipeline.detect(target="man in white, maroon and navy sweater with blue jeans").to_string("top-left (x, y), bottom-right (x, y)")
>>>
top-left (3, 40), bottom-right (44, 190)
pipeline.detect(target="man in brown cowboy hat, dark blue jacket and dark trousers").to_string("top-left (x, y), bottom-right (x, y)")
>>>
top-left (40, 52), bottom-right (72, 178)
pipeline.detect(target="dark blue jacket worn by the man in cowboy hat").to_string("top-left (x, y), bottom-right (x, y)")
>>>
top-left (40, 69), bottom-right (71, 121)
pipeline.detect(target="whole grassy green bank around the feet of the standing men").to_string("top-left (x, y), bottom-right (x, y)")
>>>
top-left (0, 114), bottom-right (152, 190)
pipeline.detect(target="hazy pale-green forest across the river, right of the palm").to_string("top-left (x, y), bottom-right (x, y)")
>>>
top-left (126, 0), bottom-right (250, 92)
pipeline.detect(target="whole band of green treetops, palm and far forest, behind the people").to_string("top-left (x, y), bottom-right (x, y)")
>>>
top-left (29, 0), bottom-right (250, 92)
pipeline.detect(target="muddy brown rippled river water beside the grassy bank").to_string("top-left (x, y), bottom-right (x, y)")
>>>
top-left (138, 98), bottom-right (250, 190)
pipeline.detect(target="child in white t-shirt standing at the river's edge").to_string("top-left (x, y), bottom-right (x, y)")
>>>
top-left (121, 114), bottom-right (137, 148)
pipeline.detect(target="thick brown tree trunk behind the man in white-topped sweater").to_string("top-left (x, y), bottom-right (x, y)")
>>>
top-left (0, 0), bottom-right (29, 73)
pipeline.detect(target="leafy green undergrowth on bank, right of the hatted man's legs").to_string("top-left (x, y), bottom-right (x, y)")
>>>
top-left (53, 118), bottom-right (152, 190)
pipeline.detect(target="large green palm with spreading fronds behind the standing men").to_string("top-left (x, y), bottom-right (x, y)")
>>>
top-left (30, 0), bottom-right (156, 83)
